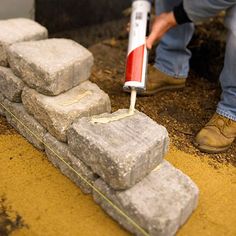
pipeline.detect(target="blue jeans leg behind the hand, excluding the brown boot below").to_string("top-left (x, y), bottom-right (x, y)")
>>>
top-left (154, 0), bottom-right (194, 78)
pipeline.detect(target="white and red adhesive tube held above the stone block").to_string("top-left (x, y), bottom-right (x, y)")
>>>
top-left (124, 0), bottom-right (151, 91)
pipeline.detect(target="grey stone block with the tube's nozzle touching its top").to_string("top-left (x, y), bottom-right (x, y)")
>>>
top-left (67, 110), bottom-right (169, 189)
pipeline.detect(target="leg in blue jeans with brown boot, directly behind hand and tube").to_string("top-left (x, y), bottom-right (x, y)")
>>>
top-left (142, 0), bottom-right (194, 96)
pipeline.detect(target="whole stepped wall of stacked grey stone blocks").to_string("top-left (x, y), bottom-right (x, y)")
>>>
top-left (0, 19), bottom-right (198, 236)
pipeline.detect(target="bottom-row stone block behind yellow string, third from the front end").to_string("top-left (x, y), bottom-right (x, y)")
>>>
top-left (4, 99), bottom-right (47, 150)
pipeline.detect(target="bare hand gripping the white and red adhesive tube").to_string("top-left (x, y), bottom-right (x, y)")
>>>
top-left (146, 12), bottom-right (177, 49)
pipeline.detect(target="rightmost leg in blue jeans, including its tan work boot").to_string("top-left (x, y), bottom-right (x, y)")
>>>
top-left (194, 5), bottom-right (236, 153)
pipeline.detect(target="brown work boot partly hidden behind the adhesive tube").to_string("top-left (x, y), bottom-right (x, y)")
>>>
top-left (140, 66), bottom-right (186, 96)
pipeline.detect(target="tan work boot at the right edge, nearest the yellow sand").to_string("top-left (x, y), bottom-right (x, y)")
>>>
top-left (194, 113), bottom-right (236, 153)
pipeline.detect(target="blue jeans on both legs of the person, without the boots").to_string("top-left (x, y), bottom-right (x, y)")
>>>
top-left (154, 0), bottom-right (236, 121)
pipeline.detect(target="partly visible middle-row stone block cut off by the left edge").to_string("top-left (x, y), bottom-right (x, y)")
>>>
top-left (0, 66), bottom-right (25, 102)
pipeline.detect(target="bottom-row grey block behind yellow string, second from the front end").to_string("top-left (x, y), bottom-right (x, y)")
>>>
top-left (44, 133), bottom-right (98, 194)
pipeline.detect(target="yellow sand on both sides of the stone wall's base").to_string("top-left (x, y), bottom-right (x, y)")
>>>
top-left (0, 134), bottom-right (236, 236)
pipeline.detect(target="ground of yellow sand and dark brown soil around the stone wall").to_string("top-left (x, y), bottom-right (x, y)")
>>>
top-left (0, 18), bottom-right (236, 236)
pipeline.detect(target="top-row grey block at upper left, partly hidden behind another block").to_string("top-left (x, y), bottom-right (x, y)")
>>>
top-left (0, 18), bottom-right (48, 66)
